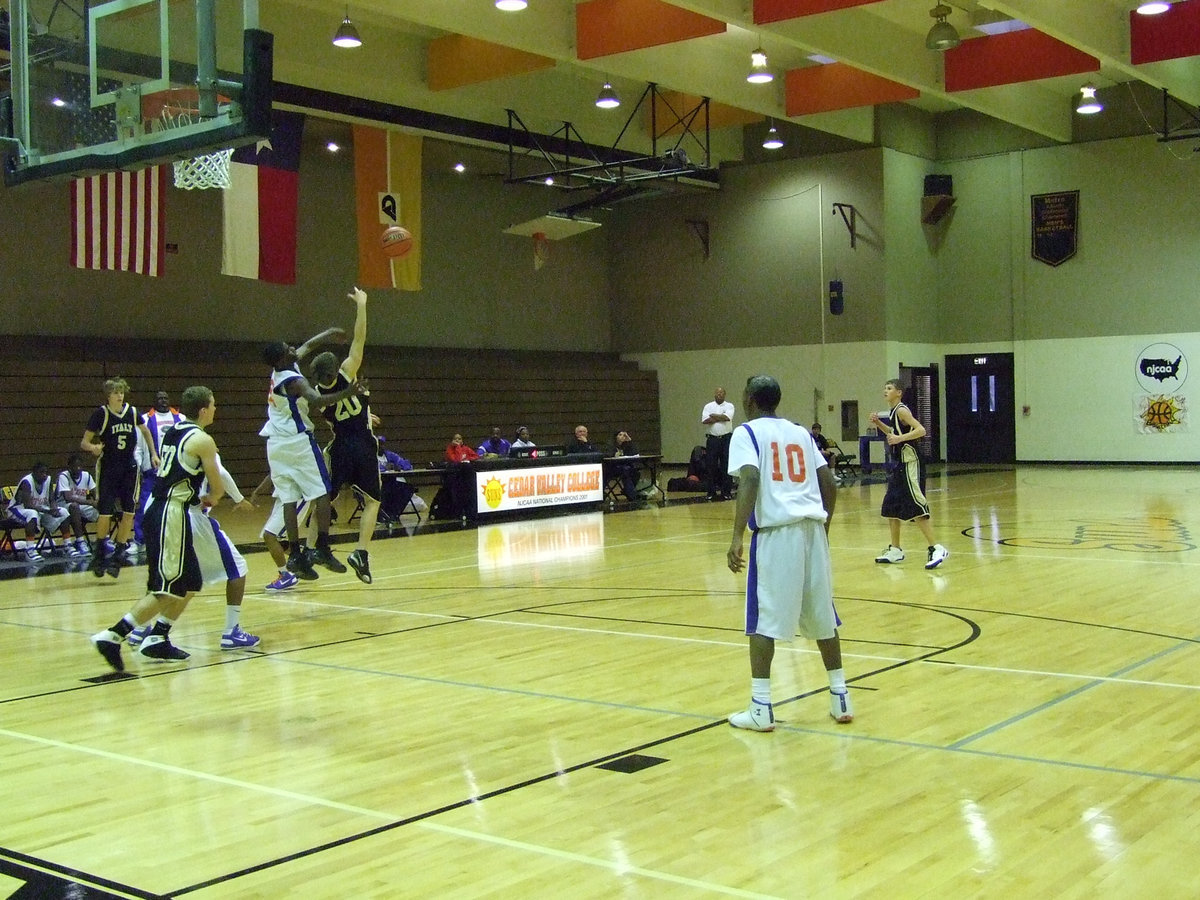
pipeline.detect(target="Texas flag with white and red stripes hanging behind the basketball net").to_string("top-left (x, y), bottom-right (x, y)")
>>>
top-left (221, 109), bottom-right (304, 284)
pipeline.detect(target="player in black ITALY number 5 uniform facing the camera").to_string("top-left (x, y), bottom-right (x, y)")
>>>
top-left (79, 378), bottom-right (158, 578)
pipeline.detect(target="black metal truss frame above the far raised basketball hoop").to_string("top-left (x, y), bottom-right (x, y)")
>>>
top-left (505, 82), bottom-right (716, 192)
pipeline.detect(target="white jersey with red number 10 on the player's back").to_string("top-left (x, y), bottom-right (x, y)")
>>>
top-left (730, 416), bottom-right (827, 530)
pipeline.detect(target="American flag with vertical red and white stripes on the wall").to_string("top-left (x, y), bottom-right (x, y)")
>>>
top-left (71, 166), bottom-right (167, 277)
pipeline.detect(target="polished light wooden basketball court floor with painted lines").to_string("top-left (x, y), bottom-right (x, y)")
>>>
top-left (0, 467), bottom-right (1200, 900)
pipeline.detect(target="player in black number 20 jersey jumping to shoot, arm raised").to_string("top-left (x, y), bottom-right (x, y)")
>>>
top-left (312, 288), bottom-right (383, 584)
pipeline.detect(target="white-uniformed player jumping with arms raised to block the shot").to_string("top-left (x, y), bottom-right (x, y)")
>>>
top-left (265, 329), bottom-right (366, 575)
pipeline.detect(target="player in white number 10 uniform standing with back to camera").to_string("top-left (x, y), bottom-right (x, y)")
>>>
top-left (726, 376), bottom-right (854, 731)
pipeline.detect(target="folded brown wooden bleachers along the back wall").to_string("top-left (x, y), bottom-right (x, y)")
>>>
top-left (0, 337), bottom-right (661, 490)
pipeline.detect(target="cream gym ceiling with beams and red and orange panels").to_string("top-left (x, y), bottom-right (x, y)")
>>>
top-left (262, 0), bottom-right (1200, 166)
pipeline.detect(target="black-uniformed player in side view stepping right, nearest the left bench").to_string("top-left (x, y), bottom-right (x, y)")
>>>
top-left (91, 386), bottom-right (224, 672)
